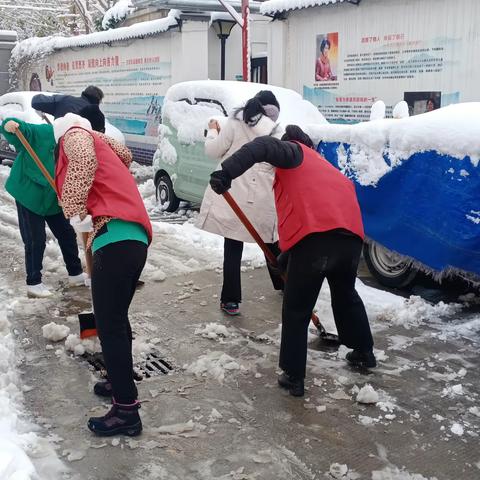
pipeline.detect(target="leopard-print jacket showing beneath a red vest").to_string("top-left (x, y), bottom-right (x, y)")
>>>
top-left (62, 128), bottom-right (132, 248)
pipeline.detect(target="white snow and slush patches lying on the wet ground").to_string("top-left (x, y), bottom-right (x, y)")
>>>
top-left (0, 165), bottom-right (480, 480)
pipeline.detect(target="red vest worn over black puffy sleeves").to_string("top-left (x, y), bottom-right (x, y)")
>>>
top-left (273, 144), bottom-right (364, 251)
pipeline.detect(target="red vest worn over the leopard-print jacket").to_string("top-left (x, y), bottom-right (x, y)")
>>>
top-left (55, 127), bottom-right (152, 243)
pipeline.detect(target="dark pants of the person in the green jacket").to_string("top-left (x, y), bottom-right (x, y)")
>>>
top-left (17, 202), bottom-right (83, 285)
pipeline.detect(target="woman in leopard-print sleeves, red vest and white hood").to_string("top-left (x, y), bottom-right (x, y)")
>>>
top-left (54, 107), bottom-right (152, 436)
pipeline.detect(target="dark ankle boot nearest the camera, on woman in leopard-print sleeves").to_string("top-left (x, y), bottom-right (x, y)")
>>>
top-left (87, 399), bottom-right (142, 437)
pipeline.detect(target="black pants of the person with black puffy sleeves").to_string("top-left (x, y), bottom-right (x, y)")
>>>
top-left (280, 232), bottom-right (373, 378)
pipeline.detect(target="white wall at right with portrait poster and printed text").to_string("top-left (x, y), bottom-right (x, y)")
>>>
top-left (269, 0), bottom-right (480, 122)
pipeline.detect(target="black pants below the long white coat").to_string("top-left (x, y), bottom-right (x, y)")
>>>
top-left (220, 238), bottom-right (284, 303)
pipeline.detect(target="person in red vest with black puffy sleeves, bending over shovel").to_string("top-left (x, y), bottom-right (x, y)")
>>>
top-left (210, 125), bottom-right (376, 396)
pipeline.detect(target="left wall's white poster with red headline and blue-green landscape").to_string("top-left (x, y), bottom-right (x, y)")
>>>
top-left (23, 37), bottom-right (172, 160)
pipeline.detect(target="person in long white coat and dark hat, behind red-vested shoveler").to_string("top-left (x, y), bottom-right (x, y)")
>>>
top-left (197, 90), bottom-right (283, 315)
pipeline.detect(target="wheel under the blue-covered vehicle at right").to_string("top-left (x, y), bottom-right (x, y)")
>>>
top-left (363, 242), bottom-right (418, 288)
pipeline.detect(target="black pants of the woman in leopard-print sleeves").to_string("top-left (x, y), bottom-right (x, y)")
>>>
top-left (92, 240), bottom-right (147, 404)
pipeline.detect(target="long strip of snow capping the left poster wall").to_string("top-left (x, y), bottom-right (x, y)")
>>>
top-left (12, 10), bottom-right (180, 61)
